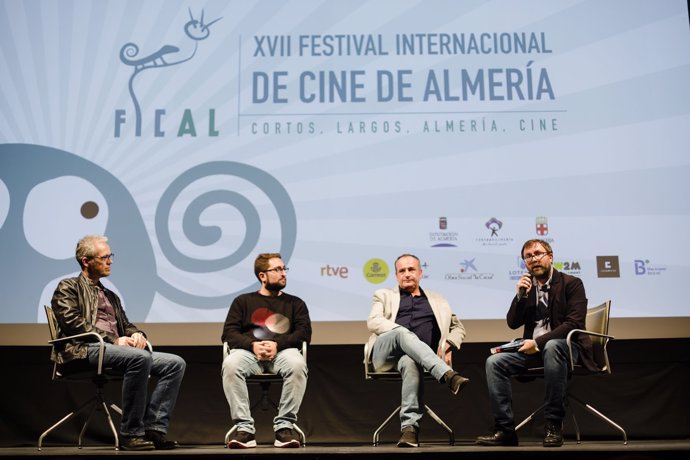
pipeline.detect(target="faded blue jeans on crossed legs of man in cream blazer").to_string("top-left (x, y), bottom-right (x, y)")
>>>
top-left (371, 327), bottom-right (452, 429)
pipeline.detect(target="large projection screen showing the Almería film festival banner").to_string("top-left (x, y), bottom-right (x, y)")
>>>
top-left (0, 0), bottom-right (690, 344)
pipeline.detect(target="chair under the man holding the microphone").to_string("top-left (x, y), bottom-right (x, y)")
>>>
top-left (515, 300), bottom-right (628, 444)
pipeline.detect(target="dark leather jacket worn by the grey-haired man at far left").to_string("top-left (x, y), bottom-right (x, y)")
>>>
top-left (51, 274), bottom-right (146, 364)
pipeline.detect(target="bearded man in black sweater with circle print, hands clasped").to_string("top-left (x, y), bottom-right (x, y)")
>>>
top-left (221, 253), bottom-right (311, 449)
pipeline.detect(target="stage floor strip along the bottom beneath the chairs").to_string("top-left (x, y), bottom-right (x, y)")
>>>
top-left (0, 440), bottom-right (690, 460)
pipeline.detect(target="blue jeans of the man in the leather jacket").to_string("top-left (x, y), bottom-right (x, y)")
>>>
top-left (88, 343), bottom-right (186, 436)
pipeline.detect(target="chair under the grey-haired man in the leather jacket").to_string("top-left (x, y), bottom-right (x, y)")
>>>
top-left (38, 305), bottom-right (122, 450)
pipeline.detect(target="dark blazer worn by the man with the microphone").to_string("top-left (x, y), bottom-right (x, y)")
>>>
top-left (506, 269), bottom-right (597, 370)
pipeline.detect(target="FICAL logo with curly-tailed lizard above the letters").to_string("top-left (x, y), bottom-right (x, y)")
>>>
top-left (114, 9), bottom-right (222, 137)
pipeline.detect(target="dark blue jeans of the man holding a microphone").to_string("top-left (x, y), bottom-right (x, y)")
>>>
top-left (486, 339), bottom-right (579, 431)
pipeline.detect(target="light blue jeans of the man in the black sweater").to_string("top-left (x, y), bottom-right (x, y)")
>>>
top-left (221, 348), bottom-right (308, 433)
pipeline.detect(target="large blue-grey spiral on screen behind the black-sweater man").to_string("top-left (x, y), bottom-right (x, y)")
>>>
top-left (155, 161), bottom-right (297, 308)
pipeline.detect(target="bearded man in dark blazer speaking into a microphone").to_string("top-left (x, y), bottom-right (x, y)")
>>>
top-left (476, 239), bottom-right (596, 447)
